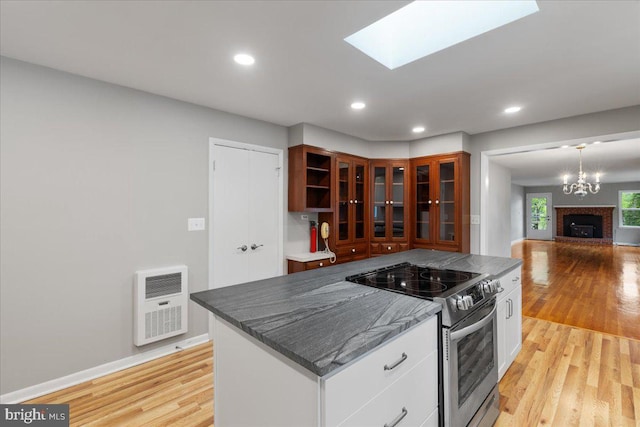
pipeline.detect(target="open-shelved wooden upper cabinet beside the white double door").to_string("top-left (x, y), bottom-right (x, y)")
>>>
top-left (289, 145), bottom-right (335, 212)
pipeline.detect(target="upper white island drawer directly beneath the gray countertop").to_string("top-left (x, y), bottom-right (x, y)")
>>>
top-left (323, 316), bottom-right (438, 426)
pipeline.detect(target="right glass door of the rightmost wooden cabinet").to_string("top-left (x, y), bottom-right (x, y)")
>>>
top-left (435, 159), bottom-right (459, 243)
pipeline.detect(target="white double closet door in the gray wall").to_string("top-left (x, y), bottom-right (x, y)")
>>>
top-left (209, 139), bottom-right (284, 288)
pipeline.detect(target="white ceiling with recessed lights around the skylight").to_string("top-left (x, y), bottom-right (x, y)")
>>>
top-left (0, 0), bottom-right (640, 186)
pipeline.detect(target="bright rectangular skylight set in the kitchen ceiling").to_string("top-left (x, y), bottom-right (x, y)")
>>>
top-left (344, 0), bottom-right (539, 70)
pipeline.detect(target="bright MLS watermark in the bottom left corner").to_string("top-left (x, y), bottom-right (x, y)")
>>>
top-left (0, 404), bottom-right (69, 427)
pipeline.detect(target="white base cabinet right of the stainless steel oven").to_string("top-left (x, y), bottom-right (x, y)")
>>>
top-left (498, 268), bottom-right (522, 379)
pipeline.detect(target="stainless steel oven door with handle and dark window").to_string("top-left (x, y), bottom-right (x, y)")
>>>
top-left (443, 297), bottom-right (498, 427)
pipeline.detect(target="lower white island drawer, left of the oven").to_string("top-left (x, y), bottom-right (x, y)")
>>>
top-left (340, 352), bottom-right (438, 427)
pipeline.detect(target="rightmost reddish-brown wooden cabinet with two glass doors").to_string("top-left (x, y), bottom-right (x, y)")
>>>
top-left (411, 152), bottom-right (470, 253)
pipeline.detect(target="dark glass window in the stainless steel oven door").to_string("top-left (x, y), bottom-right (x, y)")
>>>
top-left (457, 323), bottom-right (495, 406)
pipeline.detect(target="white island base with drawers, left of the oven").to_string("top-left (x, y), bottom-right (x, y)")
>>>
top-left (214, 316), bottom-right (438, 427)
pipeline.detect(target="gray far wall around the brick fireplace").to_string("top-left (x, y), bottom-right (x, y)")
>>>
top-left (525, 182), bottom-right (640, 245)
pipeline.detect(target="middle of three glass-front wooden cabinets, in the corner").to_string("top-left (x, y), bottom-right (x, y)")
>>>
top-left (370, 160), bottom-right (409, 255)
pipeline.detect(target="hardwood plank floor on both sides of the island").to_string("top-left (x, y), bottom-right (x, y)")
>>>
top-left (23, 241), bottom-right (640, 427)
